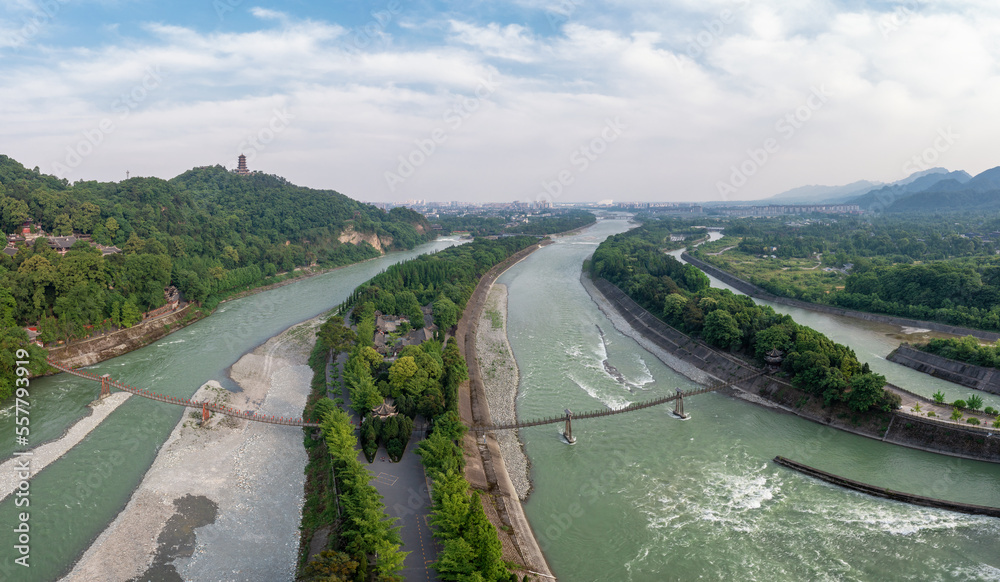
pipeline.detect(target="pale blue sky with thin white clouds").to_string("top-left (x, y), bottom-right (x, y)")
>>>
top-left (0, 0), bottom-right (1000, 203)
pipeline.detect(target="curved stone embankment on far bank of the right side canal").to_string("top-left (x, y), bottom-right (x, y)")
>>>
top-left (681, 253), bottom-right (1000, 342)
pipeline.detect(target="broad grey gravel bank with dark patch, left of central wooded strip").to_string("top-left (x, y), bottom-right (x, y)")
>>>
top-left (64, 317), bottom-right (322, 582)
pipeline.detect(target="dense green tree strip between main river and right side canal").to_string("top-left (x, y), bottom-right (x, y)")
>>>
top-left (590, 221), bottom-right (899, 412)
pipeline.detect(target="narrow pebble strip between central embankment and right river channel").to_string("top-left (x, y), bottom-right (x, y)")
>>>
top-left (476, 283), bottom-right (531, 501)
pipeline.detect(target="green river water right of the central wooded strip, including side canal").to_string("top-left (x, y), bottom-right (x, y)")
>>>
top-left (499, 220), bottom-right (1000, 582)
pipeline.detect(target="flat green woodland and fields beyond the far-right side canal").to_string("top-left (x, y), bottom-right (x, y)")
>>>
top-left (694, 213), bottom-right (1000, 330)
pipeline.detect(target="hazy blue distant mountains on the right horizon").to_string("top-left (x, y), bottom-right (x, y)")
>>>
top-left (753, 167), bottom-right (1000, 212)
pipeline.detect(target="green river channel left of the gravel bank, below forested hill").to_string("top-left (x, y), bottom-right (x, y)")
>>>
top-left (0, 239), bottom-right (459, 582)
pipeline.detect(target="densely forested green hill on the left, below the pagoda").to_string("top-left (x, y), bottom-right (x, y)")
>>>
top-left (0, 156), bottom-right (434, 356)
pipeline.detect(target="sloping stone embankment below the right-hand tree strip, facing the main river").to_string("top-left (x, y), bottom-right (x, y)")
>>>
top-left (584, 275), bottom-right (1000, 462)
